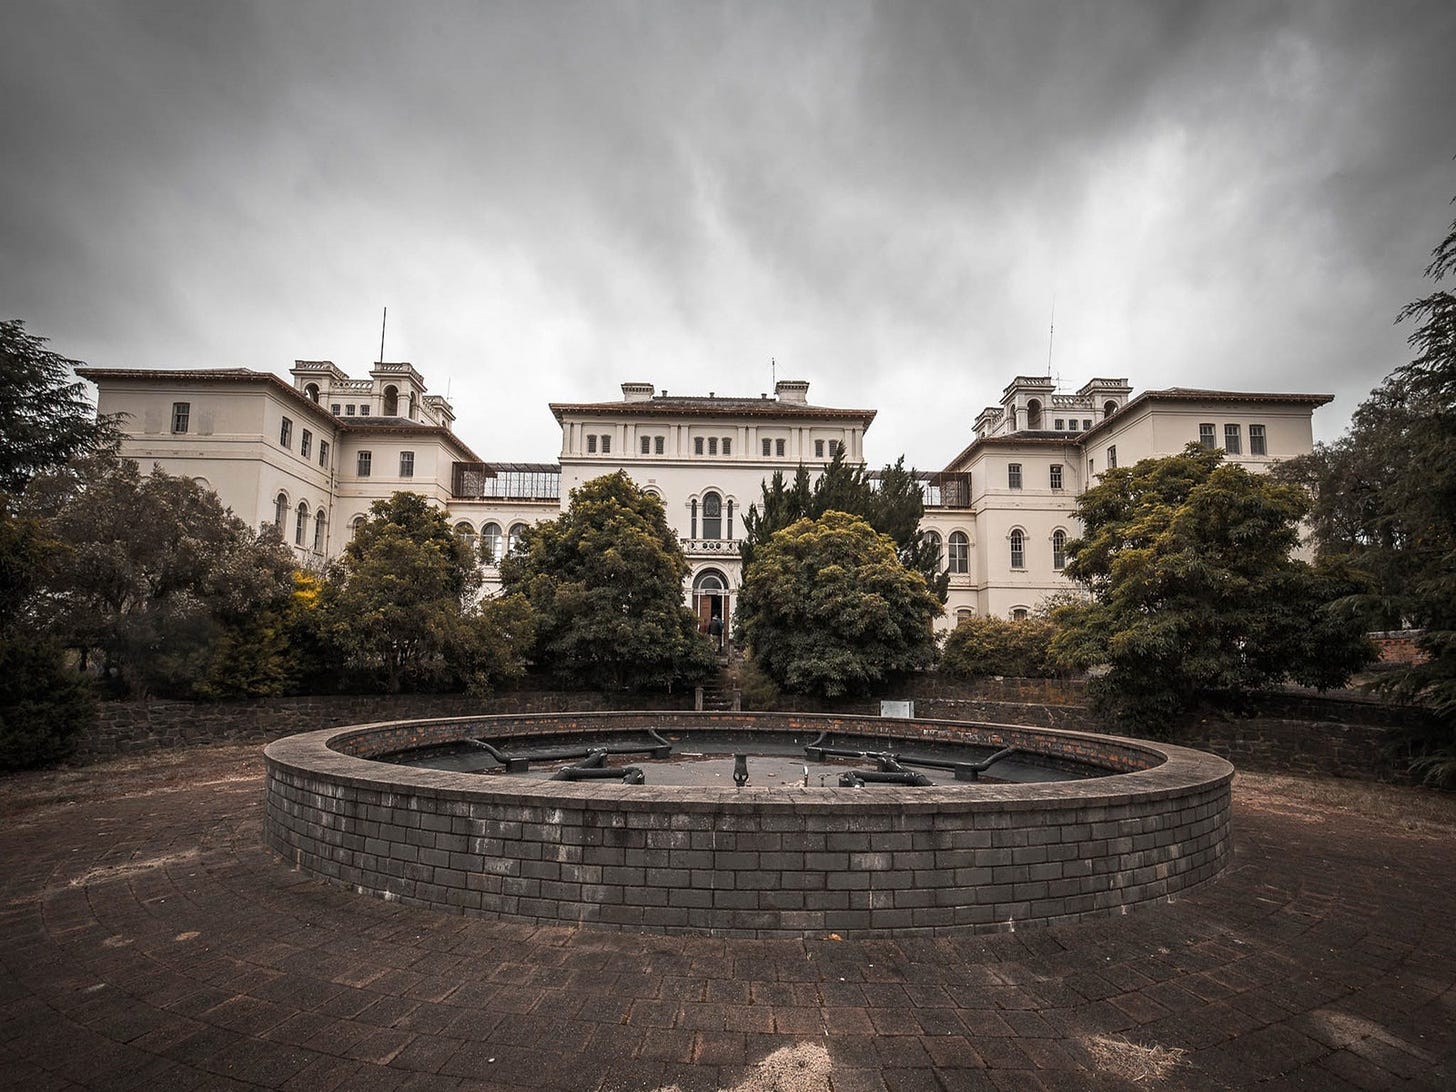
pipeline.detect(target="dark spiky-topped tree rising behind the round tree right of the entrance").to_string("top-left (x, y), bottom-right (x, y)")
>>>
top-left (740, 448), bottom-right (951, 603)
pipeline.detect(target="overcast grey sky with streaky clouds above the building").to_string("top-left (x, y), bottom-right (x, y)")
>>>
top-left (0, 0), bottom-right (1456, 469)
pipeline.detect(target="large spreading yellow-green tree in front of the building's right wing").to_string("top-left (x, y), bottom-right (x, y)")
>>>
top-left (1053, 444), bottom-right (1374, 731)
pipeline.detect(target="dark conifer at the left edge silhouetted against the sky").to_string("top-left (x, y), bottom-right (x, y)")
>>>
top-left (0, 320), bottom-right (116, 494)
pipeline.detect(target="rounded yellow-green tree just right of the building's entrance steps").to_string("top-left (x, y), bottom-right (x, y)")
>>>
top-left (738, 511), bottom-right (941, 697)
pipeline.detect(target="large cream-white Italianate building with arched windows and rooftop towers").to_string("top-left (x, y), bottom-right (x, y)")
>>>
top-left (79, 361), bottom-right (1331, 626)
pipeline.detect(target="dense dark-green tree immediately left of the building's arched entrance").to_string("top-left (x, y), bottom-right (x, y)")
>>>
top-left (501, 472), bottom-right (715, 690)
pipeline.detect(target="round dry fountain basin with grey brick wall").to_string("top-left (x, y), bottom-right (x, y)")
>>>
top-left (264, 712), bottom-right (1233, 936)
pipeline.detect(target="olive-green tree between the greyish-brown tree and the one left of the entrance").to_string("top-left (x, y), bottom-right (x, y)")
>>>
top-left (317, 492), bottom-right (529, 693)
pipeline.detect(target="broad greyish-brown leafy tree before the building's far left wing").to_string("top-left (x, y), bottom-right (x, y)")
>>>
top-left (22, 453), bottom-right (293, 696)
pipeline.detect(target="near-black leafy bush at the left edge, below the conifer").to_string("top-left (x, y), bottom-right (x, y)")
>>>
top-left (0, 495), bottom-right (96, 770)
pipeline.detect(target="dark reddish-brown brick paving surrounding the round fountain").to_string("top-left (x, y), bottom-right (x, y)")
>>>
top-left (0, 748), bottom-right (1456, 1092)
